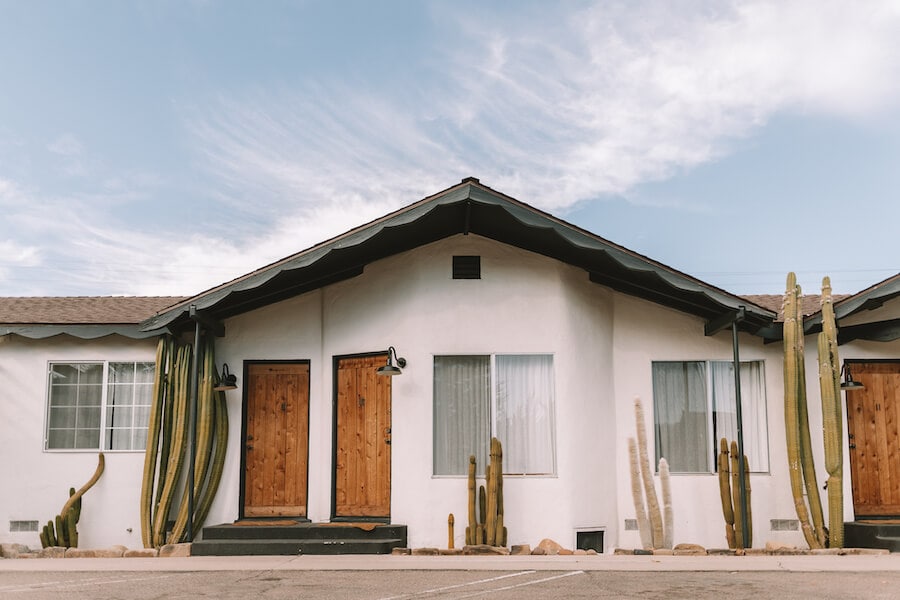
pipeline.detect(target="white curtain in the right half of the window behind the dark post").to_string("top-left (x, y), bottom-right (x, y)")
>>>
top-left (710, 361), bottom-right (769, 473)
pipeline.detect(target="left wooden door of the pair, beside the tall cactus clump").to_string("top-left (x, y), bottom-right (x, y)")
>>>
top-left (243, 363), bottom-right (309, 517)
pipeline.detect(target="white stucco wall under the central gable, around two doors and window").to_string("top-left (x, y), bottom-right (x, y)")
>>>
top-left (210, 235), bottom-right (617, 546)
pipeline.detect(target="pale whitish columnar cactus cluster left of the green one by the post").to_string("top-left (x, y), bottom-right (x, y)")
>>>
top-left (628, 398), bottom-right (672, 548)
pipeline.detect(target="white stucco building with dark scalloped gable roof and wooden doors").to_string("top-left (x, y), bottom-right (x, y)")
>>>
top-left (0, 178), bottom-right (900, 552)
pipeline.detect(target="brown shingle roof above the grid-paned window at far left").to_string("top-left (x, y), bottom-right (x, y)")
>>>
top-left (0, 296), bottom-right (184, 325)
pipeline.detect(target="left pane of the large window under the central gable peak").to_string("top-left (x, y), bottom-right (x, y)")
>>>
top-left (434, 356), bottom-right (491, 475)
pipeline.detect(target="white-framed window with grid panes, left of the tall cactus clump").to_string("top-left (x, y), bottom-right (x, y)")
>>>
top-left (45, 361), bottom-right (156, 450)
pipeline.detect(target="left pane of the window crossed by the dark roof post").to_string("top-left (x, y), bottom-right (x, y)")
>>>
top-left (653, 362), bottom-right (712, 473)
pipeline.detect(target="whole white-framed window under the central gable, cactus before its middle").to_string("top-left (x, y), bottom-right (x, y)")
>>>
top-left (434, 354), bottom-right (556, 475)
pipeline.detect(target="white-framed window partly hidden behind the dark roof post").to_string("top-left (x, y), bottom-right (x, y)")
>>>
top-left (652, 361), bottom-right (769, 473)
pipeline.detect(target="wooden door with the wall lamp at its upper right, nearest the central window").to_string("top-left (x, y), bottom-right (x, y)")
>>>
top-left (334, 355), bottom-right (391, 517)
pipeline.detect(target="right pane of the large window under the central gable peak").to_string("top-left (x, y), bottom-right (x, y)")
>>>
top-left (496, 355), bottom-right (556, 474)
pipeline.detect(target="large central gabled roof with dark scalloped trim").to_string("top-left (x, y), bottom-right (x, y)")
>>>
top-left (142, 178), bottom-right (776, 335)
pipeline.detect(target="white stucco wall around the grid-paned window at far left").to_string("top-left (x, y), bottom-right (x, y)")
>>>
top-left (0, 336), bottom-right (156, 548)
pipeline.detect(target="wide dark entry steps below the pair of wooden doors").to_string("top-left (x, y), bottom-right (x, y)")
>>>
top-left (191, 521), bottom-right (406, 556)
